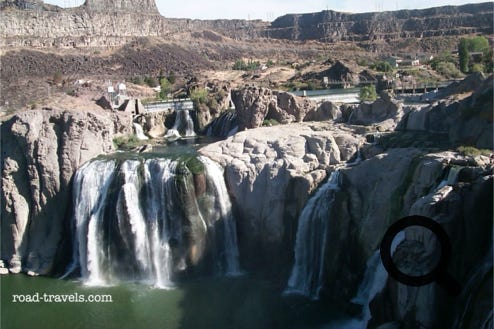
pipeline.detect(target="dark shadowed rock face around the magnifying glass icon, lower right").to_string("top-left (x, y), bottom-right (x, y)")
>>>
top-left (326, 148), bottom-right (493, 327)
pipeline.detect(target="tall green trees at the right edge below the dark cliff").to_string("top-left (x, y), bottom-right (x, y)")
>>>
top-left (458, 36), bottom-right (493, 73)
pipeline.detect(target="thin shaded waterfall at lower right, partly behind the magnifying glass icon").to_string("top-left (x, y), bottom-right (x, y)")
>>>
top-left (324, 231), bottom-right (405, 329)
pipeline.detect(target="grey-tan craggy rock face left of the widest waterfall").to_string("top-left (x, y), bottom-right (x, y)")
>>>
top-left (1, 110), bottom-right (132, 274)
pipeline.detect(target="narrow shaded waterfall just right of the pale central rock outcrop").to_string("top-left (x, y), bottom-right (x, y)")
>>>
top-left (284, 170), bottom-right (339, 299)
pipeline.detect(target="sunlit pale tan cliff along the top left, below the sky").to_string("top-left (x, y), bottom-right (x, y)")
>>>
top-left (0, 0), bottom-right (267, 48)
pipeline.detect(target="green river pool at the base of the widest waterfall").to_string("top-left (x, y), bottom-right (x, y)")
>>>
top-left (0, 275), bottom-right (340, 329)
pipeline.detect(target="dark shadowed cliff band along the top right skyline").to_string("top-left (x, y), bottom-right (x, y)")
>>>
top-left (265, 2), bottom-right (493, 42)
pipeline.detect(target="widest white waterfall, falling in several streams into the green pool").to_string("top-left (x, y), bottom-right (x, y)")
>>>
top-left (66, 157), bottom-right (240, 288)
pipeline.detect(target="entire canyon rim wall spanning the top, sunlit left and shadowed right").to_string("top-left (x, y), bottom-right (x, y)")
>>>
top-left (0, 0), bottom-right (494, 48)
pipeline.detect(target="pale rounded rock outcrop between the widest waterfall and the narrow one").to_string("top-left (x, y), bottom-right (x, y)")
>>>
top-left (200, 123), bottom-right (363, 273)
